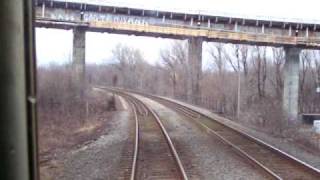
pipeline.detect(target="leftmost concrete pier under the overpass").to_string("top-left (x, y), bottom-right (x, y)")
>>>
top-left (72, 27), bottom-right (86, 92)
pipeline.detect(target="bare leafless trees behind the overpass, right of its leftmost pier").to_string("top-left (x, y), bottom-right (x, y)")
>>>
top-left (87, 41), bottom-right (320, 131)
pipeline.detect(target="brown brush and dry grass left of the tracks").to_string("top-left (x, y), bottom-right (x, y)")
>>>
top-left (38, 65), bottom-right (115, 162)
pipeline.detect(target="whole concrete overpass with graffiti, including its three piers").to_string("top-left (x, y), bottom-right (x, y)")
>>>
top-left (35, 0), bottom-right (320, 119)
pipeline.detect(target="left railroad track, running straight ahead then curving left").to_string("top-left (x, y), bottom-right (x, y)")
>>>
top-left (108, 89), bottom-right (188, 180)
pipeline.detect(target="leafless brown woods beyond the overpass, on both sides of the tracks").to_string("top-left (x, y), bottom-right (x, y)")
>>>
top-left (38, 41), bottom-right (320, 153)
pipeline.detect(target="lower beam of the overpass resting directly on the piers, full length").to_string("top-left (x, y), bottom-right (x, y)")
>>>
top-left (37, 18), bottom-right (320, 49)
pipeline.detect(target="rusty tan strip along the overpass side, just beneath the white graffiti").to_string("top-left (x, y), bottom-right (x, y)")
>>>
top-left (37, 13), bottom-right (320, 47)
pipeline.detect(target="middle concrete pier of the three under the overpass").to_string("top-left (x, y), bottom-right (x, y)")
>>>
top-left (187, 38), bottom-right (203, 103)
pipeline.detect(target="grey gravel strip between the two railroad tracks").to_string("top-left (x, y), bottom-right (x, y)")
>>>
top-left (136, 95), bottom-right (265, 179)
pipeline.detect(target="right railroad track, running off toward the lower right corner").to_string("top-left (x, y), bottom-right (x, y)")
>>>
top-left (135, 92), bottom-right (320, 180)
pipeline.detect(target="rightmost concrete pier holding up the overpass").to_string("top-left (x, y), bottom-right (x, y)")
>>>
top-left (282, 48), bottom-right (301, 121)
